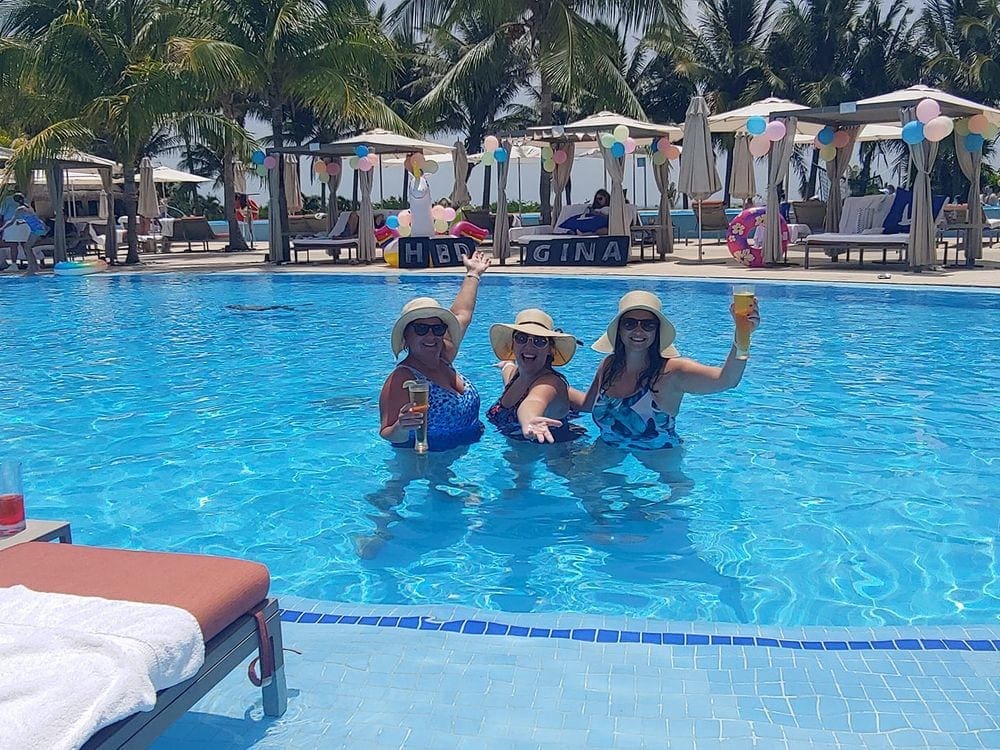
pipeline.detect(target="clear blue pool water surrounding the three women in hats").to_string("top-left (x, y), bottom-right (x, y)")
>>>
top-left (0, 274), bottom-right (1000, 625)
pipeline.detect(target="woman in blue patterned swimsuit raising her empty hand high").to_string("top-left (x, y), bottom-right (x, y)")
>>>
top-left (379, 252), bottom-right (490, 451)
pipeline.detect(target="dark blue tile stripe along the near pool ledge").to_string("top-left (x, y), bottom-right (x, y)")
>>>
top-left (281, 609), bottom-right (1000, 651)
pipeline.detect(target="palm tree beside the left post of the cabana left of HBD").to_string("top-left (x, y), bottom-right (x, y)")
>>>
top-left (172, 0), bottom-right (406, 263)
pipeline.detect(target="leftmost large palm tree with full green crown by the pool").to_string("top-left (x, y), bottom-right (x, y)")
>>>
top-left (0, 0), bottom-right (245, 263)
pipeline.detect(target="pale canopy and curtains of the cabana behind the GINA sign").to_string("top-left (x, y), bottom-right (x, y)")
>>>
top-left (516, 111), bottom-right (683, 260)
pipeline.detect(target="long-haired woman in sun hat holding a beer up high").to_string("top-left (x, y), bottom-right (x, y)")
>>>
top-left (581, 291), bottom-right (760, 450)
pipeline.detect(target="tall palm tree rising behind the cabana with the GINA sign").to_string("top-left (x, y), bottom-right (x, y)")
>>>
top-left (394, 0), bottom-right (680, 219)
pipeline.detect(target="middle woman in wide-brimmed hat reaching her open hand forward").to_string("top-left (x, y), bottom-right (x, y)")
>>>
top-left (486, 308), bottom-right (583, 443)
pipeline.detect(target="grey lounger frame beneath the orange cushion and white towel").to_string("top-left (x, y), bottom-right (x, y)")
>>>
top-left (83, 598), bottom-right (288, 750)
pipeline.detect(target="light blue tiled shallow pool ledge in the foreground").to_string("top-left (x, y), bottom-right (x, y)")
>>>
top-left (154, 597), bottom-right (1000, 750)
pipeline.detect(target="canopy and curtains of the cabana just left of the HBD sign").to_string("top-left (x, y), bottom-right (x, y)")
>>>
top-left (267, 128), bottom-right (453, 263)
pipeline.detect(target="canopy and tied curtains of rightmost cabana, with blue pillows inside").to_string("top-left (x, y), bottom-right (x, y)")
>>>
top-left (764, 86), bottom-right (1000, 271)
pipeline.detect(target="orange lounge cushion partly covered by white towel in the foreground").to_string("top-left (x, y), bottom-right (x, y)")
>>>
top-left (0, 542), bottom-right (271, 641)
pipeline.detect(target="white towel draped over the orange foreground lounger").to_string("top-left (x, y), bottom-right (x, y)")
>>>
top-left (0, 586), bottom-right (205, 750)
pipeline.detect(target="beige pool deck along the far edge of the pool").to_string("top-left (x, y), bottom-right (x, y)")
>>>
top-left (21, 241), bottom-right (1000, 288)
